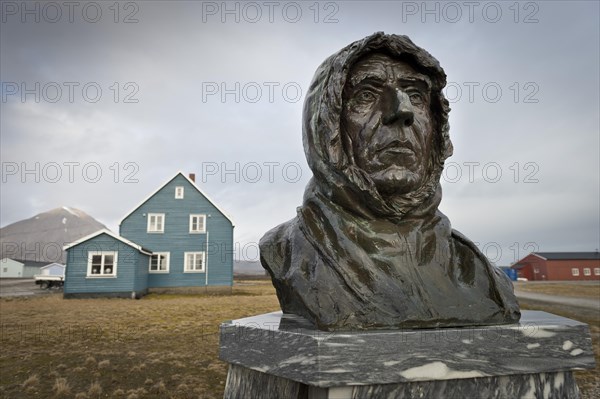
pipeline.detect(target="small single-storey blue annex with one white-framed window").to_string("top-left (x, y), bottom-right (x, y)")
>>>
top-left (63, 229), bottom-right (152, 298)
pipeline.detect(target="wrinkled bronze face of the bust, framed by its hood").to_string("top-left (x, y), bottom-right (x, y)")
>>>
top-left (342, 54), bottom-right (434, 195)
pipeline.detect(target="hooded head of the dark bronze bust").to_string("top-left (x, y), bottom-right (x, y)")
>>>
top-left (303, 33), bottom-right (452, 219)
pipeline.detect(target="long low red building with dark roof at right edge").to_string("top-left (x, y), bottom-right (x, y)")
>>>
top-left (511, 252), bottom-right (600, 281)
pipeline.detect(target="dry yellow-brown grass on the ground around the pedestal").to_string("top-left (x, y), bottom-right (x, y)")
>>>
top-left (0, 281), bottom-right (600, 399)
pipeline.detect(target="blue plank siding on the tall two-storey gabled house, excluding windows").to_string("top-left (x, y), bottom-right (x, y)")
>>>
top-left (120, 174), bottom-right (233, 288)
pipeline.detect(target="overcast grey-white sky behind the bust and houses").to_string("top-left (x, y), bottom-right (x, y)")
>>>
top-left (0, 1), bottom-right (600, 265)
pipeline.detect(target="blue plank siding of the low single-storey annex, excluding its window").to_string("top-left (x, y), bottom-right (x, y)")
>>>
top-left (64, 234), bottom-right (148, 296)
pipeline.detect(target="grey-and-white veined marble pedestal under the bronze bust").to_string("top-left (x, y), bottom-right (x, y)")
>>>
top-left (220, 311), bottom-right (595, 399)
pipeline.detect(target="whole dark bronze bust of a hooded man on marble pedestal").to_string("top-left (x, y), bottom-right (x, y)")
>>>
top-left (260, 33), bottom-right (520, 330)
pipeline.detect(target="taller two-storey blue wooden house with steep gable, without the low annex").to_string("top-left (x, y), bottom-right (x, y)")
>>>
top-left (119, 172), bottom-right (233, 288)
